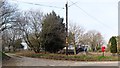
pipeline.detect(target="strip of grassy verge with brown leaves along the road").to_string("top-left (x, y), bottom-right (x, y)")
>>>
top-left (16, 52), bottom-right (118, 61)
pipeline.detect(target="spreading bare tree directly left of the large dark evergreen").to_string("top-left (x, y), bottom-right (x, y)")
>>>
top-left (16, 10), bottom-right (43, 53)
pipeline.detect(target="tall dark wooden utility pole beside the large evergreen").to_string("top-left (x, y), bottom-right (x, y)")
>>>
top-left (65, 2), bottom-right (68, 55)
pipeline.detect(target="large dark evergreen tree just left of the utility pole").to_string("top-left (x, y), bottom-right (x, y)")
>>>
top-left (41, 11), bottom-right (66, 53)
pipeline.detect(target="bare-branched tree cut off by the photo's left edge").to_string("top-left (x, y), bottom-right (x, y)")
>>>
top-left (0, 0), bottom-right (19, 49)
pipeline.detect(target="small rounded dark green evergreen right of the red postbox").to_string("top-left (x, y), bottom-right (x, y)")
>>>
top-left (109, 36), bottom-right (117, 54)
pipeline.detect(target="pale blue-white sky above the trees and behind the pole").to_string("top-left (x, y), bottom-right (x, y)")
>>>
top-left (9, 0), bottom-right (119, 42)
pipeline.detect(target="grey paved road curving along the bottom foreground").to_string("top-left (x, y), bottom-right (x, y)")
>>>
top-left (3, 54), bottom-right (118, 66)
